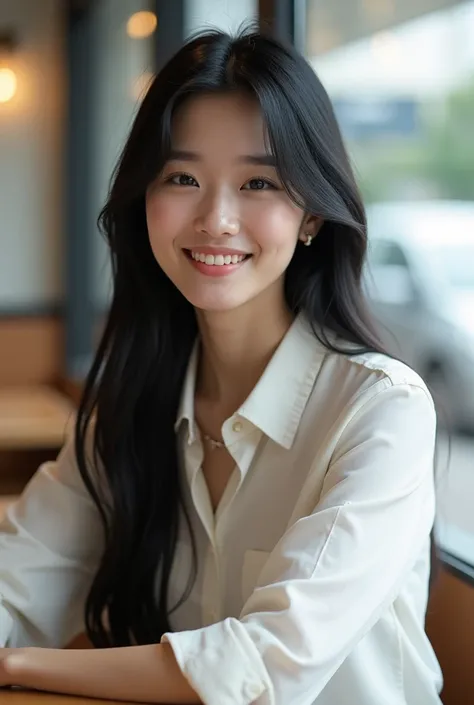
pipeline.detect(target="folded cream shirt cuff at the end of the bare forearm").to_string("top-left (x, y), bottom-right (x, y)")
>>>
top-left (161, 618), bottom-right (273, 705)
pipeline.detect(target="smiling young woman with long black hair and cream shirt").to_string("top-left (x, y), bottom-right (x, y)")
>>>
top-left (0, 27), bottom-right (441, 705)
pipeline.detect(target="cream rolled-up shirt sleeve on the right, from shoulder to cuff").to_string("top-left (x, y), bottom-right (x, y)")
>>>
top-left (163, 380), bottom-right (436, 705)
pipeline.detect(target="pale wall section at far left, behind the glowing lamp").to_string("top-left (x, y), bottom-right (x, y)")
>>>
top-left (0, 0), bottom-right (65, 311)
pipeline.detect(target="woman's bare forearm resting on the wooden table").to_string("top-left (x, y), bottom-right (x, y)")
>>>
top-left (7, 644), bottom-right (201, 705)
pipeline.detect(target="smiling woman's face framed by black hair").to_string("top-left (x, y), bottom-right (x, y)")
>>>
top-left (146, 94), bottom-right (314, 311)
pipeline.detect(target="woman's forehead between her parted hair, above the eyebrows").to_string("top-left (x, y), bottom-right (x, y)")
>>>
top-left (171, 92), bottom-right (267, 152)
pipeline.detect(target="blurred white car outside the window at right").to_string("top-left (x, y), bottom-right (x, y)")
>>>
top-left (364, 201), bottom-right (474, 433)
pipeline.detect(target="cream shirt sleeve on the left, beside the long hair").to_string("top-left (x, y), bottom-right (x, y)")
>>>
top-left (0, 441), bottom-right (103, 647)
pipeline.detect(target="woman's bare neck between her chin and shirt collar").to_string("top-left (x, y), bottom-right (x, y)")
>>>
top-left (196, 292), bottom-right (293, 414)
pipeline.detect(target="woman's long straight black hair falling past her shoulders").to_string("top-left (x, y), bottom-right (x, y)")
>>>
top-left (75, 30), bottom-right (396, 646)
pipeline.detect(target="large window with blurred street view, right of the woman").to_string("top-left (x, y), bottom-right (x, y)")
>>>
top-left (302, 0), bottom-right (474, 566)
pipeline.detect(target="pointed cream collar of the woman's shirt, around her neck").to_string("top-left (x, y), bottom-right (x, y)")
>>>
top-left (175, 315), bottom-right (327, 449)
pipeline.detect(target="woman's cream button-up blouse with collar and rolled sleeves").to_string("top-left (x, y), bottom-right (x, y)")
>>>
top-left (0, 318), bottom-right (442, 705)
